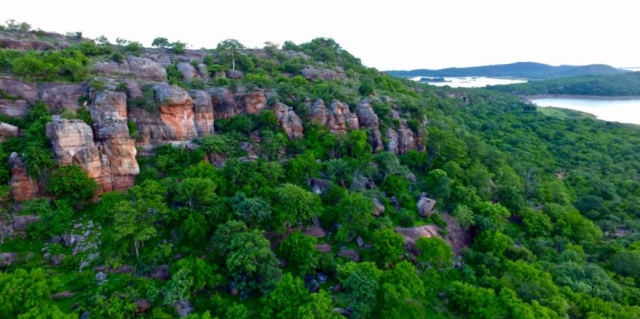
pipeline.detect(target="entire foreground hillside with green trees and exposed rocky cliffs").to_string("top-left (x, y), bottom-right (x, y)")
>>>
top-left (0, 23), bottom-right (640, 319)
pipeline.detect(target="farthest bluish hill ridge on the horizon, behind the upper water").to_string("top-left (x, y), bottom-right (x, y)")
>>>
top-left (387, 62), bottom-right (628, 79)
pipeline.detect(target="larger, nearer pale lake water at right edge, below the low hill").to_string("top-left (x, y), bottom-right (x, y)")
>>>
top-left (531, 98), bottom-right (640, 124)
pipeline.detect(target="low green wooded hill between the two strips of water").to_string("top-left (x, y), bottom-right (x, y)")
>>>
top-left (487, 72), bottom-right (640, 96)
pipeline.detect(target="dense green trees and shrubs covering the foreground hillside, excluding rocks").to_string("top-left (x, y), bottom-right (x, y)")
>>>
top-left (0, 27), bottom-right (640, 319)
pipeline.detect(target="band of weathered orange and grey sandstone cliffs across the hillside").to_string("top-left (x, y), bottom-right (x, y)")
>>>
top-left (0, 39), bottom-right (418, 200)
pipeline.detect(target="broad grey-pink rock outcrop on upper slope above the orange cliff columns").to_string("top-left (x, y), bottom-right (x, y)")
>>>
top-left (94, 56), bottom-right (167, 81)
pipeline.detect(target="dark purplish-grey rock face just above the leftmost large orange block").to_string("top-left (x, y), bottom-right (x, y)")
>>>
top-left (38, 83), bottom-right (87, 111)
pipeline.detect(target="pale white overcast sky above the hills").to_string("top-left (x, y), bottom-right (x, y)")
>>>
top-left (0, 0), bottom-right (640, 70)
